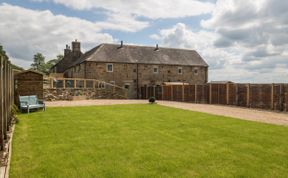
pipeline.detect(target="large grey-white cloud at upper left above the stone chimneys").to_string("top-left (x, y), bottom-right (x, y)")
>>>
top-left (0, 4), bottom-right (114, 67)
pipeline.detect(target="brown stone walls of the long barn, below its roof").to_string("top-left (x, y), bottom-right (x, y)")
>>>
top-left (66, 62), bottom-right (208, 98)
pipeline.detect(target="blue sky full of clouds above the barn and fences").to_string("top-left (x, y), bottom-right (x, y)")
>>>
top-left (0, 0), bottom-right (288, 83)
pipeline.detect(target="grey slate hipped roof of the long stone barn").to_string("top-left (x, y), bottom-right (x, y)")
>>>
top-left (68, 44), bottom-right (208, 68)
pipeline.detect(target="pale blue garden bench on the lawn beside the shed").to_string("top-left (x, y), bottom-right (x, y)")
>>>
top-left (19, 95), bottom-right (46, 114)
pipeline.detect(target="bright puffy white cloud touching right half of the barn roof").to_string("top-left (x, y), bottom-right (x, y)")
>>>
top-left (151, 23), bottom-right (238, 70)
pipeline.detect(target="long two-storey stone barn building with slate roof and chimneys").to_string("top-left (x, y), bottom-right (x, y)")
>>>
top-left (51, 41), bottom-right (208, 98)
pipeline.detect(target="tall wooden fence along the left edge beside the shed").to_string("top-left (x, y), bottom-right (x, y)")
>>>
top-left (0, 55), bottom-right (14, 150)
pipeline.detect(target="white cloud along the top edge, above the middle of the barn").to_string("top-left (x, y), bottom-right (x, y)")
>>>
top-left (32, 0), bottom-right (214, 32)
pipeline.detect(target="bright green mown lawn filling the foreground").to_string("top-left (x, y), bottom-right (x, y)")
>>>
top-left (10, 104), bottom-right (288, 178)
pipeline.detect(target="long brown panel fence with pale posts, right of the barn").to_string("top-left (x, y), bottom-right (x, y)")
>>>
top-left (140, 83), bottom-right (288, 111)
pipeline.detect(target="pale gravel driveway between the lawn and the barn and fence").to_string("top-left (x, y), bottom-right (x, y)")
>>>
top-left (46, 99), bottom-right (288, 125)
